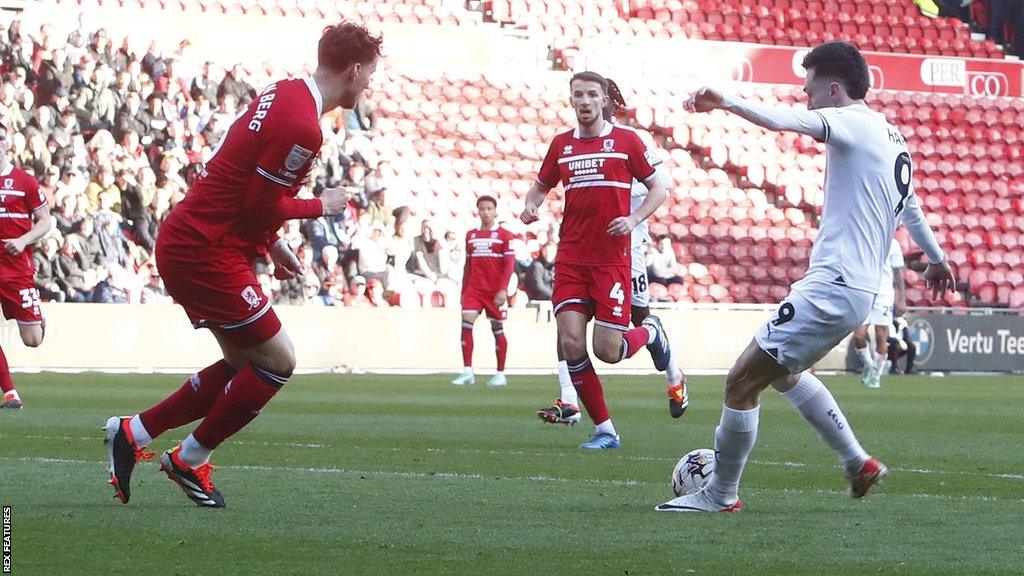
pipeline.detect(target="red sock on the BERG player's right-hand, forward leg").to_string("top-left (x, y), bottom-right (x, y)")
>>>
top-left (193, 364), bottom-right (289, 450)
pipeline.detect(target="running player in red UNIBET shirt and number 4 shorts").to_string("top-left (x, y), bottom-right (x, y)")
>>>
top-left (520, 72), bottom-right (671, 450)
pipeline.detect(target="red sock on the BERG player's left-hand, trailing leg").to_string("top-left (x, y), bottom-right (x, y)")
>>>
top-left (138, 360), bottom-right (234, 438)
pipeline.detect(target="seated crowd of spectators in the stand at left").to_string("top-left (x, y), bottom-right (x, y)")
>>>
top-left (0, 20), bottom-right (528, 306)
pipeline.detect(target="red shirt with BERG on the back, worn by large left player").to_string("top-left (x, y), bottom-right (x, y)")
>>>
top-left (161, 79), bottom-right (324, 246)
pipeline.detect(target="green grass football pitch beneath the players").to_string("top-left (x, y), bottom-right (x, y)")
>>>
top-left (0, 374), bottom-right (1024, 576)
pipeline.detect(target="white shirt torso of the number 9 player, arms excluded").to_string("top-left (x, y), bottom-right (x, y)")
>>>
top-left (807, 105), bottom-right (913, 294)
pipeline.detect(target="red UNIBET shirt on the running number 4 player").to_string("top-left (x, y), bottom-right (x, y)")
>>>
top-left (537, 122), bottom-right (654, 265)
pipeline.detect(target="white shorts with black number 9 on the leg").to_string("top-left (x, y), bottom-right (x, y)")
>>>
top-left (754, 278), bottom-right (874, 374)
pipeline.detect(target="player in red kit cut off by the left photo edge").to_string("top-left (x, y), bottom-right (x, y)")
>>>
top-left (0, 119), bottom-right (50, 409)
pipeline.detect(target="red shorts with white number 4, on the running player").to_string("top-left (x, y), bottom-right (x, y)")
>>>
top-left (551, 262), bottom-right (633, 332)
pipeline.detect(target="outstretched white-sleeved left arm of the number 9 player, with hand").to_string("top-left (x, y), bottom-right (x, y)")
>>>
top-left (684, 87), bottom-right (826, 141)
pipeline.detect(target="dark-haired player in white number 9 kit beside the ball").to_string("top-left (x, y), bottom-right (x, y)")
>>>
top-left (655, 42), bottom-right (954, 511)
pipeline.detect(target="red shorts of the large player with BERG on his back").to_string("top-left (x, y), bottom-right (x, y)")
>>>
top-left (156, 231), bottom-right (281, 347)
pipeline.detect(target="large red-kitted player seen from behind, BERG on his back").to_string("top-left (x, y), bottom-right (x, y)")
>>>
top-left (105, 23), bottom-right (381, 507)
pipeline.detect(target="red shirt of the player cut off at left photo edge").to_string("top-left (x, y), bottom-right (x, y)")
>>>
top-left (0, 164), bottom-right (46, 278)
